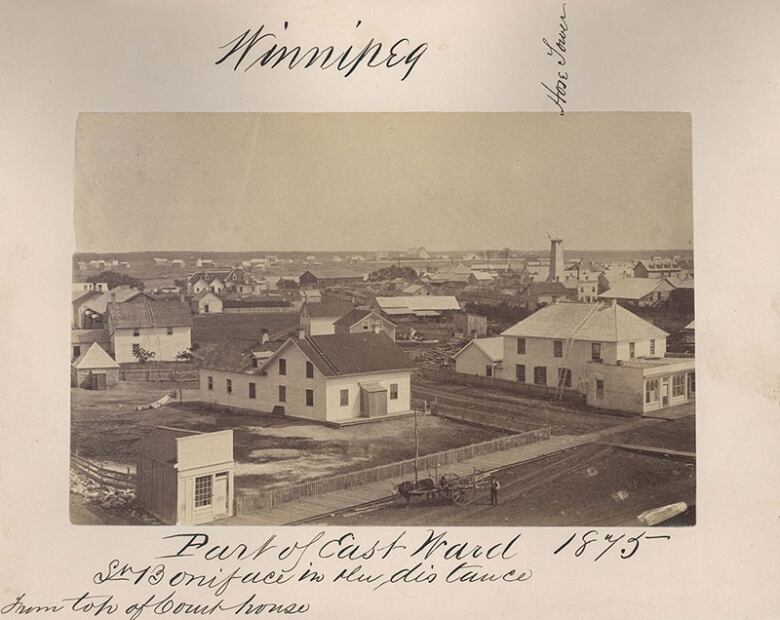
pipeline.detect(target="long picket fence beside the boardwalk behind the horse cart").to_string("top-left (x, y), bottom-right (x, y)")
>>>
top-left (236, 427), bottom-right (550, 512)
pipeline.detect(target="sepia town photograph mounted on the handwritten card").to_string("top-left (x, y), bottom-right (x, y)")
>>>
top-left (70, 112), bottom-right (696, 527)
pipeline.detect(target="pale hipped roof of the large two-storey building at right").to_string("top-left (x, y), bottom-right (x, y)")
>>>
top-left (501, 303), bottom-right (669, 342)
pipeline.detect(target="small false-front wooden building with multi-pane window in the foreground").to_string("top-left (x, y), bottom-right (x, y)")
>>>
top-left (135, 426), bottom-right (234, 525)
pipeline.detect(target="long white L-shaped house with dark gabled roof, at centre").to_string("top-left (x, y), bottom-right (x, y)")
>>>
top-left (200, 333), bottom-right (413, 422)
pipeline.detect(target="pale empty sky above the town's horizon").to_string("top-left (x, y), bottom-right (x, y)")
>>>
top-left (74, 112), bottom-right (693, 252)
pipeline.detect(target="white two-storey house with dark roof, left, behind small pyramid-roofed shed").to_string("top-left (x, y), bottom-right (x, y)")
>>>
top-left (106, 300), bottom-right (192, 364)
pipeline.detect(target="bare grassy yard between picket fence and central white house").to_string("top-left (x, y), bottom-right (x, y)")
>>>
top-left (71, 382), bottom-right (501, 488)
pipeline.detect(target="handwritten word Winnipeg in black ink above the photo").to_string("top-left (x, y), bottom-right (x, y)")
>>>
top-left (214, 20), bottom-right (428, 82)
